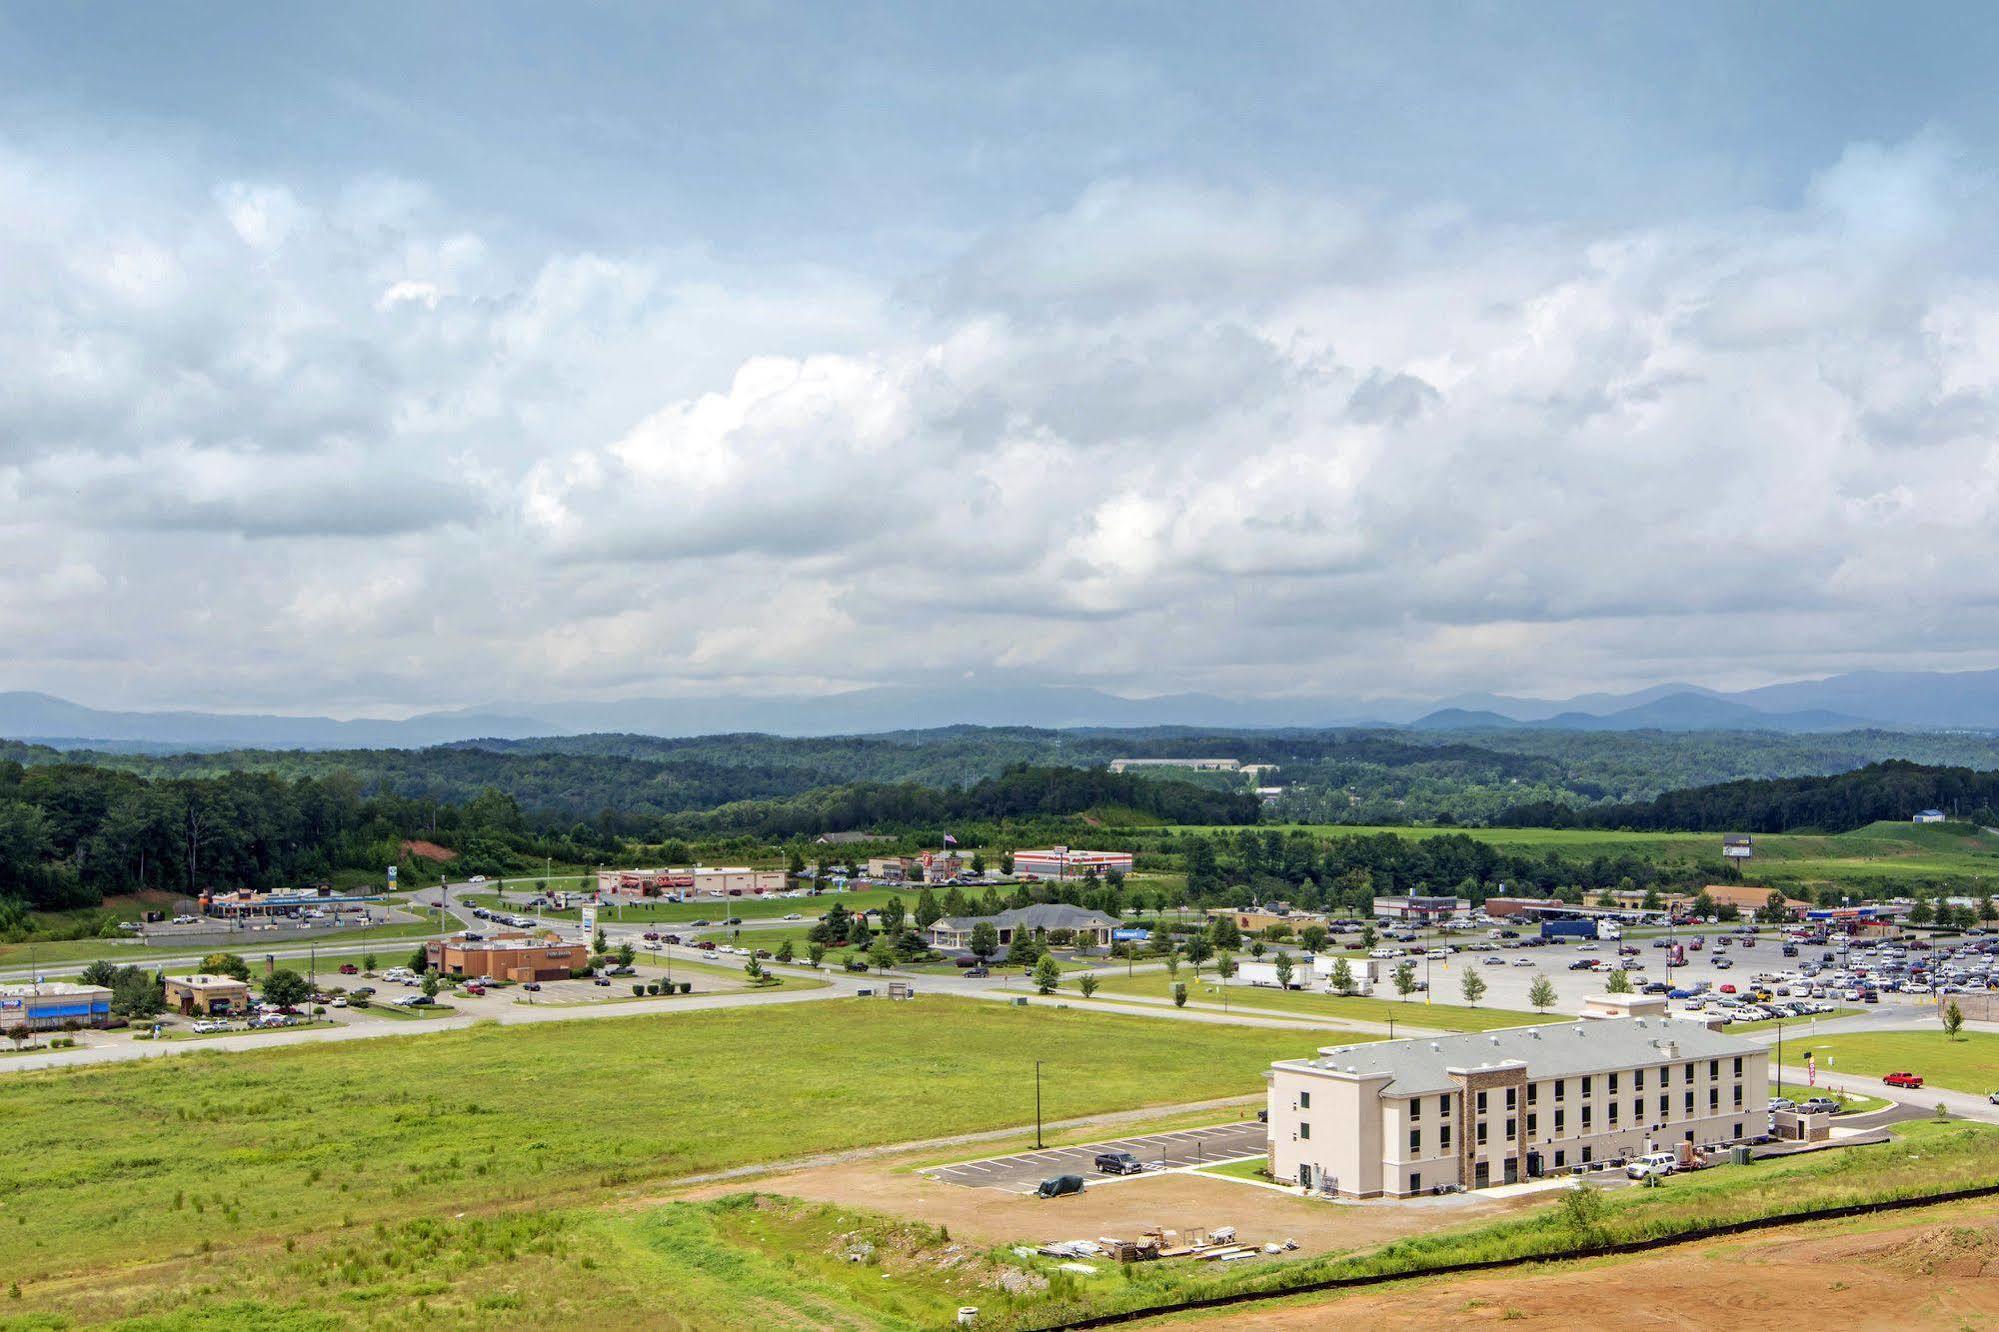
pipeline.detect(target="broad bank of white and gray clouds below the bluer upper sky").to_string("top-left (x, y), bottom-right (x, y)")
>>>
top-left (0, 136), bottom-right (1999, 706)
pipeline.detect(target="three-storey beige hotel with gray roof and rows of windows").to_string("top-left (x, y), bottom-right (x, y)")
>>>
top-left (1267, 1018), bottom-right (1769, 1198)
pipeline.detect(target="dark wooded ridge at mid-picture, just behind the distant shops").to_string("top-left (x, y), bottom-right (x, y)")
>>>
top-left (664, 766), bottom-right (1259, 842)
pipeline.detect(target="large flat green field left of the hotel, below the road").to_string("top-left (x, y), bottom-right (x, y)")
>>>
top-left (0, 998), bottom-right (1301, 1312)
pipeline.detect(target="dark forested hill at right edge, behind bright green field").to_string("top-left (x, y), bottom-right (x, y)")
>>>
top-left (1495, 760), bottom-right (1999, 832)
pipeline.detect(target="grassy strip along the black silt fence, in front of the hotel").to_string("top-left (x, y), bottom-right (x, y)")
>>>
top-left (998, 1122), bottom-right (1999, 1328)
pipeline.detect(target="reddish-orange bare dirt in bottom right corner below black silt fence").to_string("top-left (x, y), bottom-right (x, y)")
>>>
top-left (1175, 1204), bottom-right (1999, 1332)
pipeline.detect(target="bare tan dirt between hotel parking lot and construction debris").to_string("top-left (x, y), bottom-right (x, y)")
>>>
top-left (686, 1158), bottom-right (1545, 1254)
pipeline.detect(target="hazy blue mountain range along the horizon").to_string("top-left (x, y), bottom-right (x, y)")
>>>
top-left (11, 670), bottom-right (1999, 750)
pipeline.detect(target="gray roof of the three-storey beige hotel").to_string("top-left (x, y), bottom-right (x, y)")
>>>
top-left (1309, 1018), bottom-right (1763, 1096)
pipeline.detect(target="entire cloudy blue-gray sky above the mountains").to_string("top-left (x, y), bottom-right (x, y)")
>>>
top-left (0, 2), bottom-right (1999, 714)
